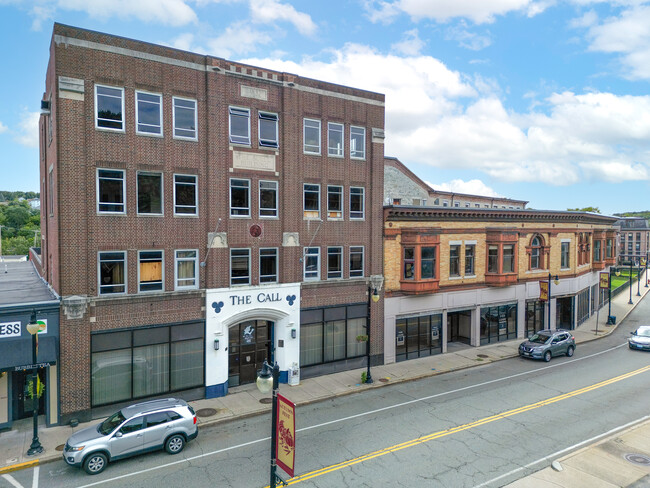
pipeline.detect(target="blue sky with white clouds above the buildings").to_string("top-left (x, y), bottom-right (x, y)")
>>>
top-left (0, 0), bottom-right (650, 214)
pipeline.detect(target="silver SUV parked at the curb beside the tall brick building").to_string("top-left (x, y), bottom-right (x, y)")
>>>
top-left (63, 398), bottom-right (199, 474)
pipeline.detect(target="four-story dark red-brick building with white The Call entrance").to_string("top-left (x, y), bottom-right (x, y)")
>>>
top-left (40, 24), bottom-right (384, 422)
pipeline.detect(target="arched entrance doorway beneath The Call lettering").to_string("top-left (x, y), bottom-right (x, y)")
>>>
top-left (228, 320), bottom-right (274, 387)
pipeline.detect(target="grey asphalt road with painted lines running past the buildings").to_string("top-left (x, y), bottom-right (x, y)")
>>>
top-left (5, 300), bottom-right (650, 488)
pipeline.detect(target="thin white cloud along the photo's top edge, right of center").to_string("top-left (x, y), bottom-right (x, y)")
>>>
top-left (365, 0), bottom-right (540, 24)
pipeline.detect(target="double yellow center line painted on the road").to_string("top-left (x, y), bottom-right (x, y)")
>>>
top-left (276, 365), bottom-right (650, 488)
